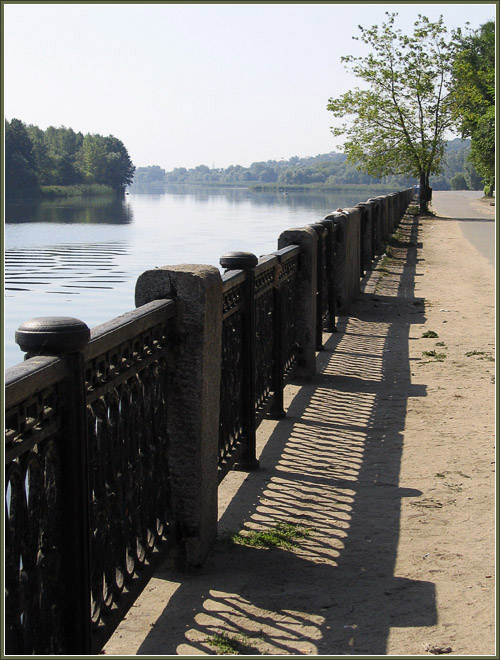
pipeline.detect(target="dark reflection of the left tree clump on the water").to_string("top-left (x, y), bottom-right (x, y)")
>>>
top-left (5, 196), bottom-right (133, 225)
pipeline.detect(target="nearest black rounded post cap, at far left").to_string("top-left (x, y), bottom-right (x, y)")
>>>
top-left (15, 316), bottom-right (90, 355)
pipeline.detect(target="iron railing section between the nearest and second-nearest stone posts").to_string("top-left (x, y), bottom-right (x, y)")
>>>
top-left (219, 246), bottom-right (300, 481)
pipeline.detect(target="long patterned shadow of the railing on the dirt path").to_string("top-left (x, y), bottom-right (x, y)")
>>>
top-left (110, 217), bottom-right (436, 655)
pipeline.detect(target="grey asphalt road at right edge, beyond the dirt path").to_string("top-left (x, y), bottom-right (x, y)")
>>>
top-left (431, 190), bottom-right (496, 266)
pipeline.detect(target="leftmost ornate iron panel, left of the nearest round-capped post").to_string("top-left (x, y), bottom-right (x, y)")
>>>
top-left (4, 358), bottom-right (70, 655)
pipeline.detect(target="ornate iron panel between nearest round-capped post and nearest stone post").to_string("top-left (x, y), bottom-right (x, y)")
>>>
top-left (84, 301), bottom-right (175, 649)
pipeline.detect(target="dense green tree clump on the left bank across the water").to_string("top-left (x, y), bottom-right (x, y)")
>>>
top-left (5, 119), bottom-right (135, 195)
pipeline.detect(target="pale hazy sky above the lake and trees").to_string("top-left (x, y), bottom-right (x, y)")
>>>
top-left (3, 2), bottom-right (496, 170)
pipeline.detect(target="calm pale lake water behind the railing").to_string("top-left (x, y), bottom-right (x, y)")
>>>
top-left (4, 186), bottom-right (392, 367)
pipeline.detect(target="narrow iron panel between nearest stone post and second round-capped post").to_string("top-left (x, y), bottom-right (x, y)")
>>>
top-left (219, 271), bottom-right (245, 479)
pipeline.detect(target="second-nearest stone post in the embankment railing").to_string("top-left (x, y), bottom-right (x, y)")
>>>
top-left (278, 227), bottom-right (318, 378)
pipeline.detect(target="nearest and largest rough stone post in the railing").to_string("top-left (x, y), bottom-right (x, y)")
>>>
top-left (135, 265), bottom-right (222, 567)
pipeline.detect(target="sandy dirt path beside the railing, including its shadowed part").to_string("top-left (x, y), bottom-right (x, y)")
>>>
top-left (106, 201), bottom-right (495, 656)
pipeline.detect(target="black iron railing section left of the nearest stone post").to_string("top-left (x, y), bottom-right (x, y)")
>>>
top-left (5, 301), bottom-right (180, 654)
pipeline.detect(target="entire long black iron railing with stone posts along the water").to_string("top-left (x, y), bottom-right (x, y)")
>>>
top-left (5, 190), bottom-right (412, 655)
